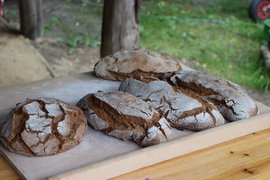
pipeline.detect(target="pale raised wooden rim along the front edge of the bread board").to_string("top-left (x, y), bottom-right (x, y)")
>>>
top-left (51, 109), bottom-right (270, 180)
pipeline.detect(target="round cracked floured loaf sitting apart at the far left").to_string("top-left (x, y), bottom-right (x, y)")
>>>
top-left (0, 98), bottom-right (87, 156)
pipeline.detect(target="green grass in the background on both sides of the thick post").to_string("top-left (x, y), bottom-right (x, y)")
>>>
top-left (5, 0), bottom-right (270, 90)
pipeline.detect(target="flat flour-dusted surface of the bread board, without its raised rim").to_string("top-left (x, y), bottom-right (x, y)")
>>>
top-left (0, 73), bottom-right (192, 179)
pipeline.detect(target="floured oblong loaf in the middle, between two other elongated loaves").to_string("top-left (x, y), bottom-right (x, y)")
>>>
top-left (119, 79), bottom-right (225, 131)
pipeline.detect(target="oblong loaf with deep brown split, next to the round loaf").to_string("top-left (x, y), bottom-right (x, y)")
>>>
top-left (78, 91), bottom-right (171, 147)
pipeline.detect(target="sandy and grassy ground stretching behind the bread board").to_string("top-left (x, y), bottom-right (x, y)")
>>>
top-left (0, 0), bottom-right (270, 105)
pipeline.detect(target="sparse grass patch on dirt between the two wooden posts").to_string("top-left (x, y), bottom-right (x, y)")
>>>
top-left (44, 0), bottom-right (102, 54)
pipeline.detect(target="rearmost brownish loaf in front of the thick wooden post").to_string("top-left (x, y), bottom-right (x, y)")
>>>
top-left (94, 49), bottom-right (181, 82)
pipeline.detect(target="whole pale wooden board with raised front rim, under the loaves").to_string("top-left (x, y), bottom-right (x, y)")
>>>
top-left (0, 73), bottom-right (270, 179)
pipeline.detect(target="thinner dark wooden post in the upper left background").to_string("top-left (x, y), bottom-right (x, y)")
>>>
top-left (19, 0), bottom-right (42, 39)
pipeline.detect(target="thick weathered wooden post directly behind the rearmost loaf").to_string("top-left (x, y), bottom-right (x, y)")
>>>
top-left (100, 0), bottom-right (140, 57)
